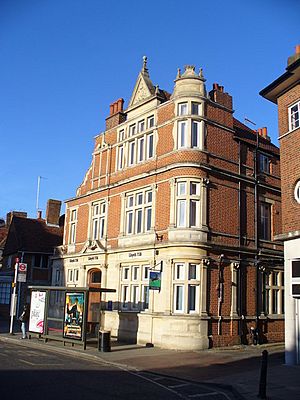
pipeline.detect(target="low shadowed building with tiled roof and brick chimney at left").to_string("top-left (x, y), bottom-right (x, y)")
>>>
top-left (0, 200), bottom-right (63, 315)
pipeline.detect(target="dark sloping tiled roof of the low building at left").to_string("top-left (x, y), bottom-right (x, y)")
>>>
top-left (3, 216), bottom-right (63, 255)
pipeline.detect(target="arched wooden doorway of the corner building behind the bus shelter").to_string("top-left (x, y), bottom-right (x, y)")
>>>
top-left (87, 268), bottom-right (102, 336)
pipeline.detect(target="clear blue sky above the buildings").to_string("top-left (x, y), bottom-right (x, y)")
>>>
top-left (0, 0), bottom-right (300, 217)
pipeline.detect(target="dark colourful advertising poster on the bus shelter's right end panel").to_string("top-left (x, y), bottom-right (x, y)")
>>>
top-left (64, 292), bottom-right (84, 340)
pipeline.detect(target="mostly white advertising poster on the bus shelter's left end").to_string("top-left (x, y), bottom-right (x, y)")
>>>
top-left (29, 291), bottom-right (46, 333)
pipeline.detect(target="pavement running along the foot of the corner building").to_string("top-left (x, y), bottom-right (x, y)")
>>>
top-left (0, 320), bottom-right (300, 400)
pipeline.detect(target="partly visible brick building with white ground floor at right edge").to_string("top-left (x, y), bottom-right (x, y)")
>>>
top-left (260, 45), bottom-right (300, 364)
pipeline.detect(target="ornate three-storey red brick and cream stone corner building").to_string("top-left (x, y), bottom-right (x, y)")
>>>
top-left (52, 57), bottom-right (284, 350)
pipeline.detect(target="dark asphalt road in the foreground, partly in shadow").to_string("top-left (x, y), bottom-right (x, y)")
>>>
top-left (0, 341), bottom-right (229, 400)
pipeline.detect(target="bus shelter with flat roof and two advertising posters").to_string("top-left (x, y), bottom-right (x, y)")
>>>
top-left (29, 286), bottom-right (116, 350)
